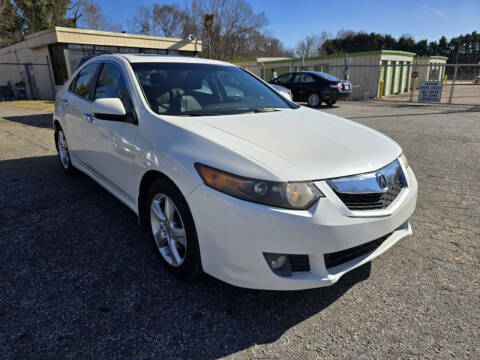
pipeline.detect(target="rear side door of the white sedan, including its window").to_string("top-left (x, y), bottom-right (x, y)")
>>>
top-left (62, 64), bottom-right (99, 163)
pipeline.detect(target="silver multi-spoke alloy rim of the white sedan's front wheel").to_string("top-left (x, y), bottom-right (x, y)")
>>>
top-left (150, 194), bottom-right (187, 267)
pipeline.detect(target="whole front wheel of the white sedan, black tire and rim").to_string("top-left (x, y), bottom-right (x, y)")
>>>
top-left (146, 179), bottom-right (202, 280)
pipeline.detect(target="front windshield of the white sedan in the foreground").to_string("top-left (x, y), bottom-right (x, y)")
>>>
top-left (132, 63), bottom-right (298, 116)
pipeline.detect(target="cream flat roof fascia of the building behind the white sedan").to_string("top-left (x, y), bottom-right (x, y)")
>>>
top-left (0, 26), bottom-right (202, 54)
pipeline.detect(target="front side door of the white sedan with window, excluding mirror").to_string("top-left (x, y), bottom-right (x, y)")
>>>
top-left (85, 62), bottom-right (138, 200)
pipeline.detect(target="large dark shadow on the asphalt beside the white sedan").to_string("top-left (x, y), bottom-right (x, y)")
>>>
top-left (0, 156), bottom-right (370, 359)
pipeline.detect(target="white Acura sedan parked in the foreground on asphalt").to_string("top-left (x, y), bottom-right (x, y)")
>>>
top-left (53, 55), bottom-right (417, 290)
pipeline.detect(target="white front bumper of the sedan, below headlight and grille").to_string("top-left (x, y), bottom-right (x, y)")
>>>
top-left (187, 168), bottom-right (417, 290)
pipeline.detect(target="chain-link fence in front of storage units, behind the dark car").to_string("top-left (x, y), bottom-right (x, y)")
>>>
top-left (244, 62), bottom-right (480, 105)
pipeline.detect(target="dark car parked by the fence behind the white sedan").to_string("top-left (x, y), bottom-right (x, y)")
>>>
top-left (271, 71), bottom-right (352, 107)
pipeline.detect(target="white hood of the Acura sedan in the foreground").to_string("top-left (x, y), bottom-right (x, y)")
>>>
top-left (164, 107), bottom-right (402, 181)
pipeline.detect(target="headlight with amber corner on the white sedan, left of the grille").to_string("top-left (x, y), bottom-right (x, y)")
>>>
top-left (195, 164), bottom-right (325, 210)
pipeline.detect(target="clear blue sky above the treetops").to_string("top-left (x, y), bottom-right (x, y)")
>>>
top-left (97, 0), bottom-right (480, 48)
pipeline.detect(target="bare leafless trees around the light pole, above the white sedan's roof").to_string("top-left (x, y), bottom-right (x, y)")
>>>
top-left (125, 0), bottom-right (292, 60)
